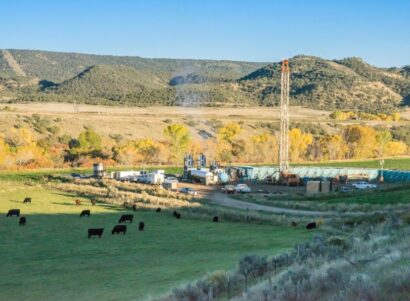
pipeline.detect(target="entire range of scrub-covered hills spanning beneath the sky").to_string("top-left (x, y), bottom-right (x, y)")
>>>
top-left (0, 50), bottom-right (410, 112)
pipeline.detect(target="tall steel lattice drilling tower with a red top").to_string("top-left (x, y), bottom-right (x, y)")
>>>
top-left (279, 60), bottom-right (290, 173)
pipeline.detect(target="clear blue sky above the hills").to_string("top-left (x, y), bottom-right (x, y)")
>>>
top-left (0, 0), bottom-right (410, 67)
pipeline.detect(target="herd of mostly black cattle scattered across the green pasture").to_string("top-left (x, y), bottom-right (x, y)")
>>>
top-left (7, 198), bottom-right (317, 233)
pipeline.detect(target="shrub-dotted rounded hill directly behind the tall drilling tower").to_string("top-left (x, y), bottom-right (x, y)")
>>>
top-left (239, 56), bottom-right (410, 110)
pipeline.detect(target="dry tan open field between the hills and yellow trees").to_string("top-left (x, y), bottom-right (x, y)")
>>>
top-left (0, 103), bottom-right (329, 139)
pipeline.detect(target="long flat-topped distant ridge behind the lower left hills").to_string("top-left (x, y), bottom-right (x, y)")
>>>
top-left (0, 49), bottom-right (266, 82)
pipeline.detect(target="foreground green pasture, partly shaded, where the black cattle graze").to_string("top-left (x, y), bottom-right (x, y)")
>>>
top-left (0, 182), bottom-right (315, 301)
